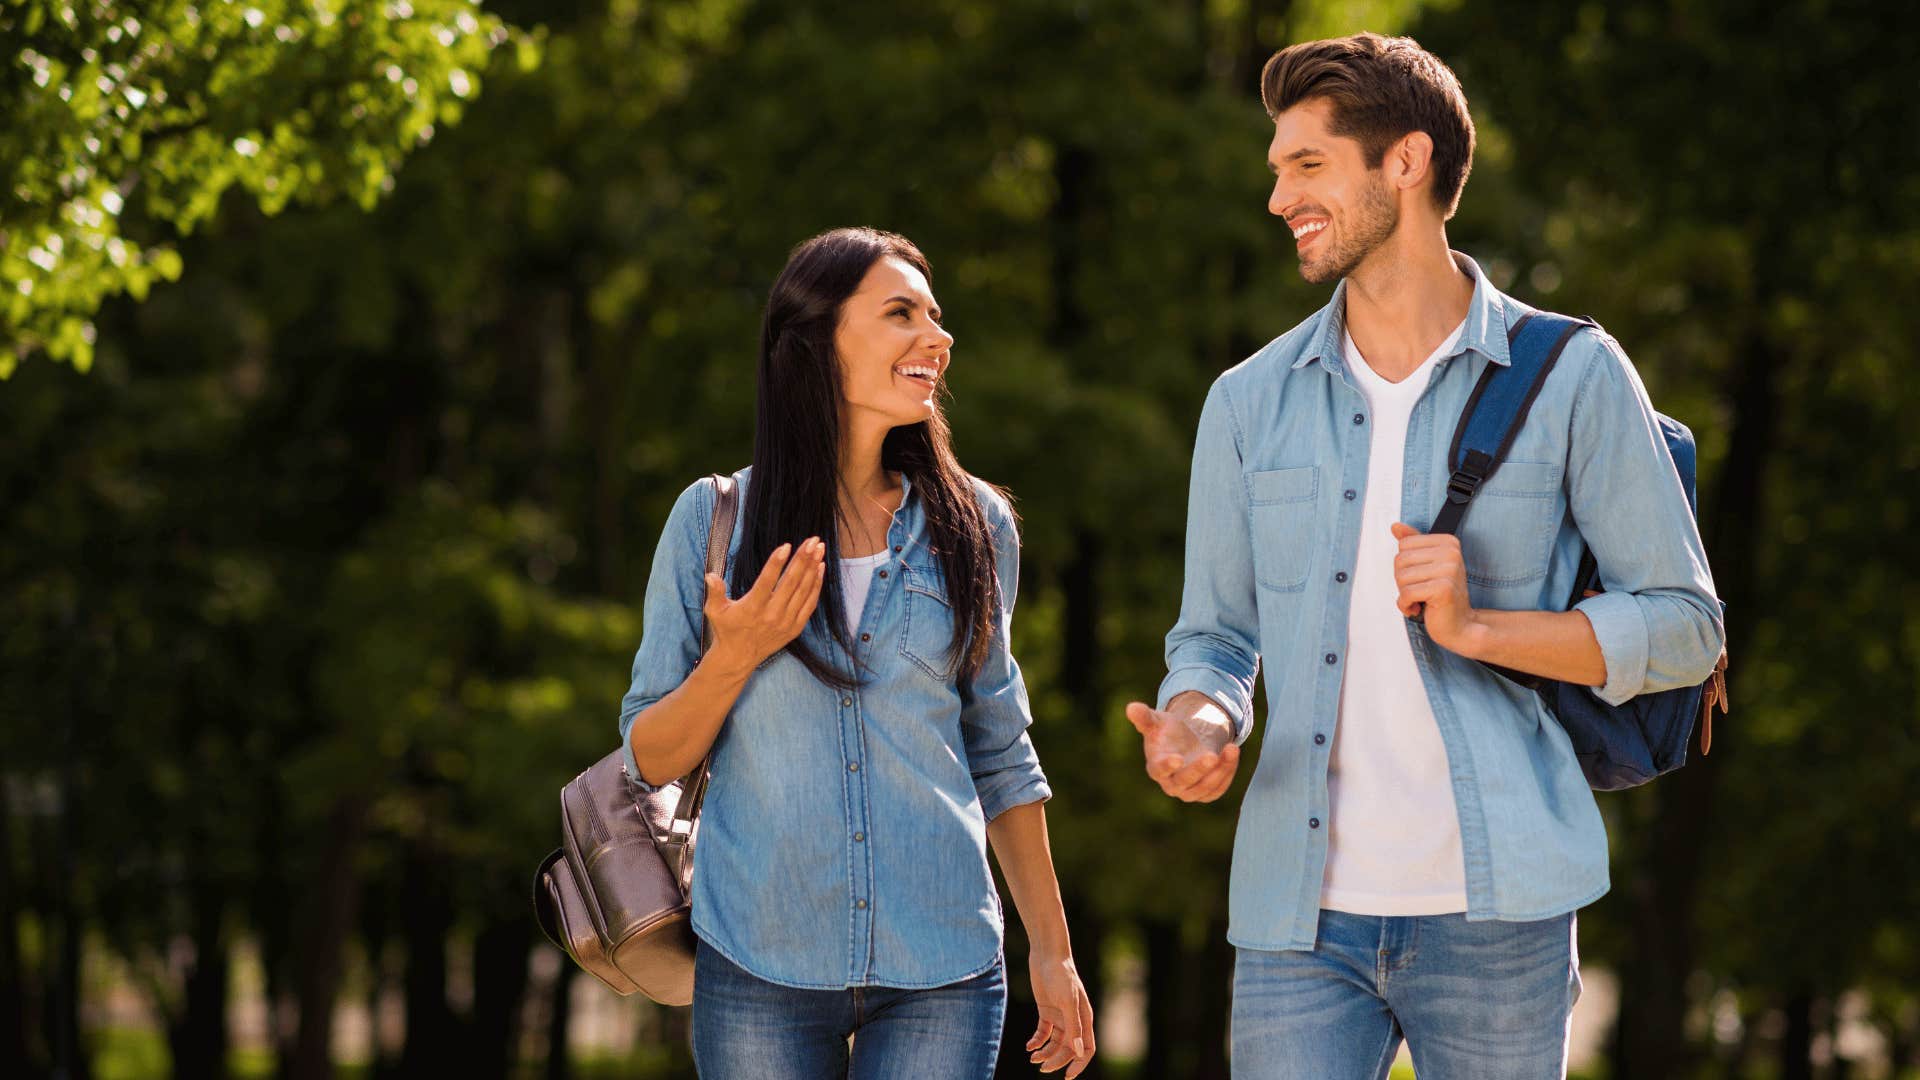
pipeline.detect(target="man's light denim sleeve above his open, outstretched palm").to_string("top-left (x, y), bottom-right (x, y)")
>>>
top-left (1160, 382), bottom-right (1260, 742)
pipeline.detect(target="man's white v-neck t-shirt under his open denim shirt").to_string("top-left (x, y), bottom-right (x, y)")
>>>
top-left (1321, 323), bottom-right (1467, 915)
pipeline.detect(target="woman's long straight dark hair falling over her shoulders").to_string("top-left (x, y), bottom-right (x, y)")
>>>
top-left (732, 229), bottom-right (1000, 688)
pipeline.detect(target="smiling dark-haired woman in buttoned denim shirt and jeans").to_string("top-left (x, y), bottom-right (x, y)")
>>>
top-left (620, 229), bottom-right (1094, 1080)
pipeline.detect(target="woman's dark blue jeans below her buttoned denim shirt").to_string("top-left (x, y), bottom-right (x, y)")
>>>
top-left (693, 942), bottom-right (1006, 1080)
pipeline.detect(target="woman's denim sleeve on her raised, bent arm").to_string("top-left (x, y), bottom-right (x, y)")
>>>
top-left (620, 480), bottom-right (714, 780)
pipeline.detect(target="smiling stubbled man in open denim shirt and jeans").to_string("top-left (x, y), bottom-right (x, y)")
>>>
top-left (1127, 35), bottom-right (1724, 1080)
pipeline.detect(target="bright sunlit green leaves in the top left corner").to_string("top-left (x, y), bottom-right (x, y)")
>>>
top-left (0, 0), bottom-right (536, 377)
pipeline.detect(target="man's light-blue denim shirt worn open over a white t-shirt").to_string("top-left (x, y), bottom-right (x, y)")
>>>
top-left (1160, 254), bottom-right (1724, 949)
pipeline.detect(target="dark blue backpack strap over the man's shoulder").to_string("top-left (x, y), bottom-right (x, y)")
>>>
top-left (1428, 309), bottom-right (1596, 534)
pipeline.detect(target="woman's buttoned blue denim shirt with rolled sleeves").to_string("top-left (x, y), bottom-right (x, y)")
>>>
top-left (620, 469), bottom-right (1052, 990)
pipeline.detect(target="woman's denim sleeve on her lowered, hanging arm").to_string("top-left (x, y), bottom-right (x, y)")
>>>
top-left (960, 490), bottom-right (1054, 821)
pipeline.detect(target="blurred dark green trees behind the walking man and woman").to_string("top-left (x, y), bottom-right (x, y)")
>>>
top-left (0, 0), bottom-right (1920, 1080)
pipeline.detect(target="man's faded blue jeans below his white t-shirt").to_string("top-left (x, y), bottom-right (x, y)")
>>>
top-left (1233, 911), bottom-right (1580, 1080)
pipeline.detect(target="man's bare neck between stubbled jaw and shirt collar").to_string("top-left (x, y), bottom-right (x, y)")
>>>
top-left (1346, 227), bottom-right (1473, 382)
